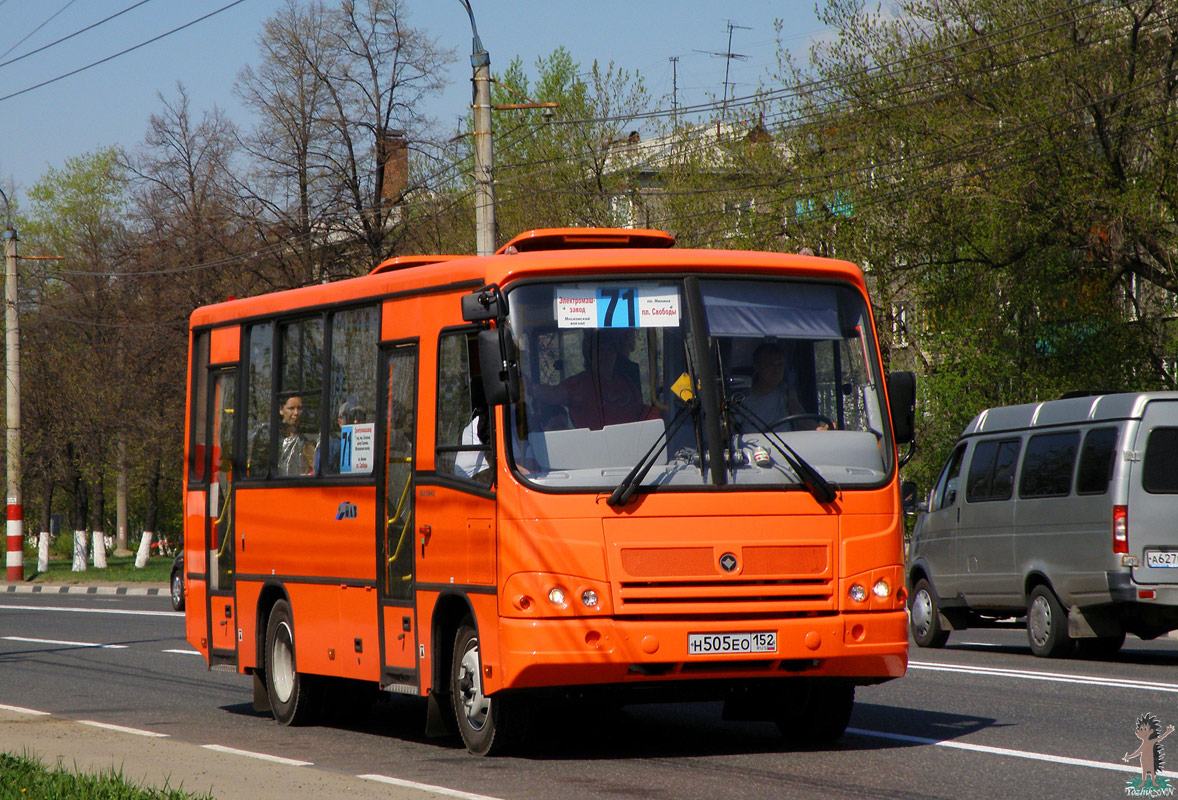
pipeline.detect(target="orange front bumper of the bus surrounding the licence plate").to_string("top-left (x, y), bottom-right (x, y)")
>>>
top-left (484, 610), bottom-right (908, 689)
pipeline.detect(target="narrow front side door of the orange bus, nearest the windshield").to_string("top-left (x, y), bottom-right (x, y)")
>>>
top-left (378, 342), bottom-right (419, 687)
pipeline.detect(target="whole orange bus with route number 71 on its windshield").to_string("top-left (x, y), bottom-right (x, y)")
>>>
top-left (184, 229), bottom-right (914, 754)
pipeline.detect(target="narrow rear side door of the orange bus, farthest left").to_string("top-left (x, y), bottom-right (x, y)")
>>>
top-left (205, 369), bottom-right (238, 665)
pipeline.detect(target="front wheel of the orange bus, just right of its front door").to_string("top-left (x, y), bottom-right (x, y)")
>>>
top-left (450, 617), bottom-right (530, 755)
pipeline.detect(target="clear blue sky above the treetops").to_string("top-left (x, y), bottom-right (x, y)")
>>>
top-left (0, 0), bottom-right (823, 205)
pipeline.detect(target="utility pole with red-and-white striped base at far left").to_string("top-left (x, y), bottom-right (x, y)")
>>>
top-left (0, 191), bottom-right (25, 581)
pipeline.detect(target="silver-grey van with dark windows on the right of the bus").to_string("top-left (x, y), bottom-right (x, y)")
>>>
top-left (907, 392), bottom-right (1178, 656)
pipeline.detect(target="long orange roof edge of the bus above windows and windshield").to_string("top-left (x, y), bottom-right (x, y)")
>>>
top-left (191, 229), bottom-right (865, 326)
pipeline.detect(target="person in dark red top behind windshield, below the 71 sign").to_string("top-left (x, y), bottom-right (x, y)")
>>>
top-left (534, 329), bottom-right (651, 430)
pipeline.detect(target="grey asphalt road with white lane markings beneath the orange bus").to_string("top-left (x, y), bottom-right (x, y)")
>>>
top-left (0, 594), bottom-right (1178, 800)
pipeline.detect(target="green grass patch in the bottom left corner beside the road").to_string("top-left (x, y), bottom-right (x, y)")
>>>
top-left (0, 753), bottom-right (213, 800)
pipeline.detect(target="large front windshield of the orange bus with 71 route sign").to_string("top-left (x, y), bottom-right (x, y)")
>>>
top-left (508, 277), bottom-right (893, 491)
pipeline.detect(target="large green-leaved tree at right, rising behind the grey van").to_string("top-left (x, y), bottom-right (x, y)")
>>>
top-left (777, 0), bottom-right (1178, 487)
